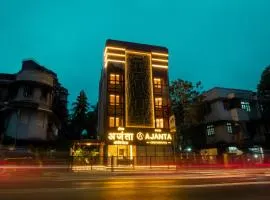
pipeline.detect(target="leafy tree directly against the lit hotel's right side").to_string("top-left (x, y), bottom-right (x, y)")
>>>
top-left (169, 79), bottom-right (204, 150)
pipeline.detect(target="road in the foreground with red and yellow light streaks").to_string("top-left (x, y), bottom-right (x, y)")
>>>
top-left (0, 170), bottom-right (270, 200)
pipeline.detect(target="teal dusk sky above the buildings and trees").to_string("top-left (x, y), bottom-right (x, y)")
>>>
top-left (0, 0), bottom-right (270, 106)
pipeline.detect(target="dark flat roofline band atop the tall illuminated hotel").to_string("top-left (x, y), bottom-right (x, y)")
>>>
top-left (106, 39), bottom-right (168, 53)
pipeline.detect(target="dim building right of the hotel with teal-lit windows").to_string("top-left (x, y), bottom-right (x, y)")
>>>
top-left (204, 87), bottom-right (265, 147)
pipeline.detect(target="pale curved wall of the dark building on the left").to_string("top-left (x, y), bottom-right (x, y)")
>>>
top-left (6, 66), bottom-right (54, 140)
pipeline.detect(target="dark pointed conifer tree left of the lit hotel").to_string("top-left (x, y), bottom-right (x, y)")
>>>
top-left (70, 90), bottom-right (90, 139)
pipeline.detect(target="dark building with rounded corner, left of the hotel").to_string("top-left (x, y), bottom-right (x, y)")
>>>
top-left (0, 60), bottom-right (68, 141)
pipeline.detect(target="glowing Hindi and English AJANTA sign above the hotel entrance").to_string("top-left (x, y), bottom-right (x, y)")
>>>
top-left (108, 132), bottom-right (173, 144)
